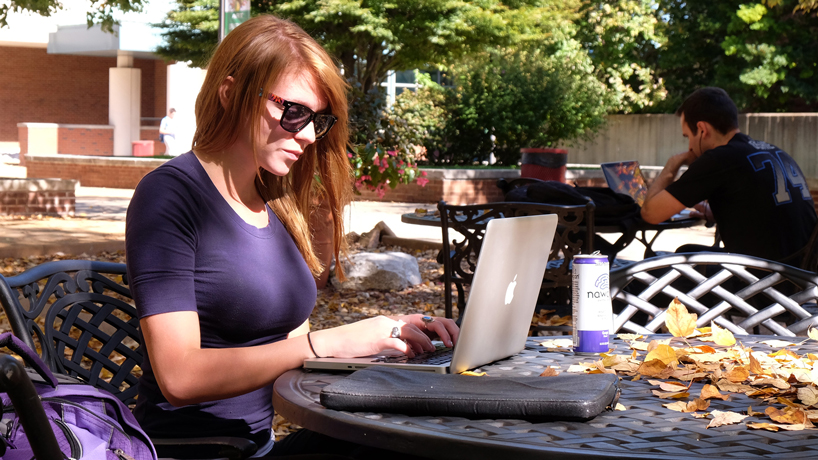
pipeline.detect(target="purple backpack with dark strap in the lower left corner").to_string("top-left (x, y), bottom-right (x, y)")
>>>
top-left (0, 332), bottom-right (156, 460)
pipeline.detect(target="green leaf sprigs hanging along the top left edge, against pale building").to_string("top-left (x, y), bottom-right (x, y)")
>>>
top-left (0, 0), bottom-right (145, 32)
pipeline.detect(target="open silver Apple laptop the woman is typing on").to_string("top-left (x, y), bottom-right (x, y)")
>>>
top-left (304, 214), bottom-right (557, 374)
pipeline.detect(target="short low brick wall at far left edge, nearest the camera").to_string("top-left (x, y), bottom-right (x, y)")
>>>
top-left (0, 179), bottom-right (77, 217)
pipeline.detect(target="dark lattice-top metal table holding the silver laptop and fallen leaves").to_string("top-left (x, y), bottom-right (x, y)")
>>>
top-left (273, 336), bottom-right (818, 460)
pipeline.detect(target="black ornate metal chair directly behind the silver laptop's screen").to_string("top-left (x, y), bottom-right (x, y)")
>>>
top-left (437, 201), bottom-right (594, 318)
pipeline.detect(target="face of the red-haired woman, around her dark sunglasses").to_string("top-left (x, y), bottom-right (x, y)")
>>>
top-left (256, 73), bottom-right (328, 176)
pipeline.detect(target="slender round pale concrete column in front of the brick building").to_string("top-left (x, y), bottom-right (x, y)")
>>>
top-left (108, 51), bottom-right (142, 157)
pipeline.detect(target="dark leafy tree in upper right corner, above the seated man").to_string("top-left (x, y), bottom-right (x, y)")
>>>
top-left (656, 0), bottom-right (818, 111)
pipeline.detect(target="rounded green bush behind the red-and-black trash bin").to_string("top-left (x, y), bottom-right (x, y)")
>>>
top-left (390, 39), bottom-right (617, 165)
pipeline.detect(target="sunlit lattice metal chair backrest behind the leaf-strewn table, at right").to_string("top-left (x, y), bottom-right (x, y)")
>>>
top-left (610, 253), bottom-right (818, 336)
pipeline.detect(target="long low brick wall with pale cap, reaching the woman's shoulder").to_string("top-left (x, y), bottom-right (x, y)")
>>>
top-left (21, 154), bottom-right (167, 188)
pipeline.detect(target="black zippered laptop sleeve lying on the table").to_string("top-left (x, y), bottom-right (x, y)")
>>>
top-left (320, 367), bottom-right (619, 422)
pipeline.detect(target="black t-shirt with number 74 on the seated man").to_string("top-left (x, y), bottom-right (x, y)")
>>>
top-left (666, 133), bottom-right (818, 260)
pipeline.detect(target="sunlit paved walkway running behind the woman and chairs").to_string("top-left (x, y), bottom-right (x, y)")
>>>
top-left (0, 182), bottom-right (713, 260)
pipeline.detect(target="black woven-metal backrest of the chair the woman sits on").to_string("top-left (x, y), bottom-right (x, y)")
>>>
top-left (0, 260), bottom-right (143, 404)
